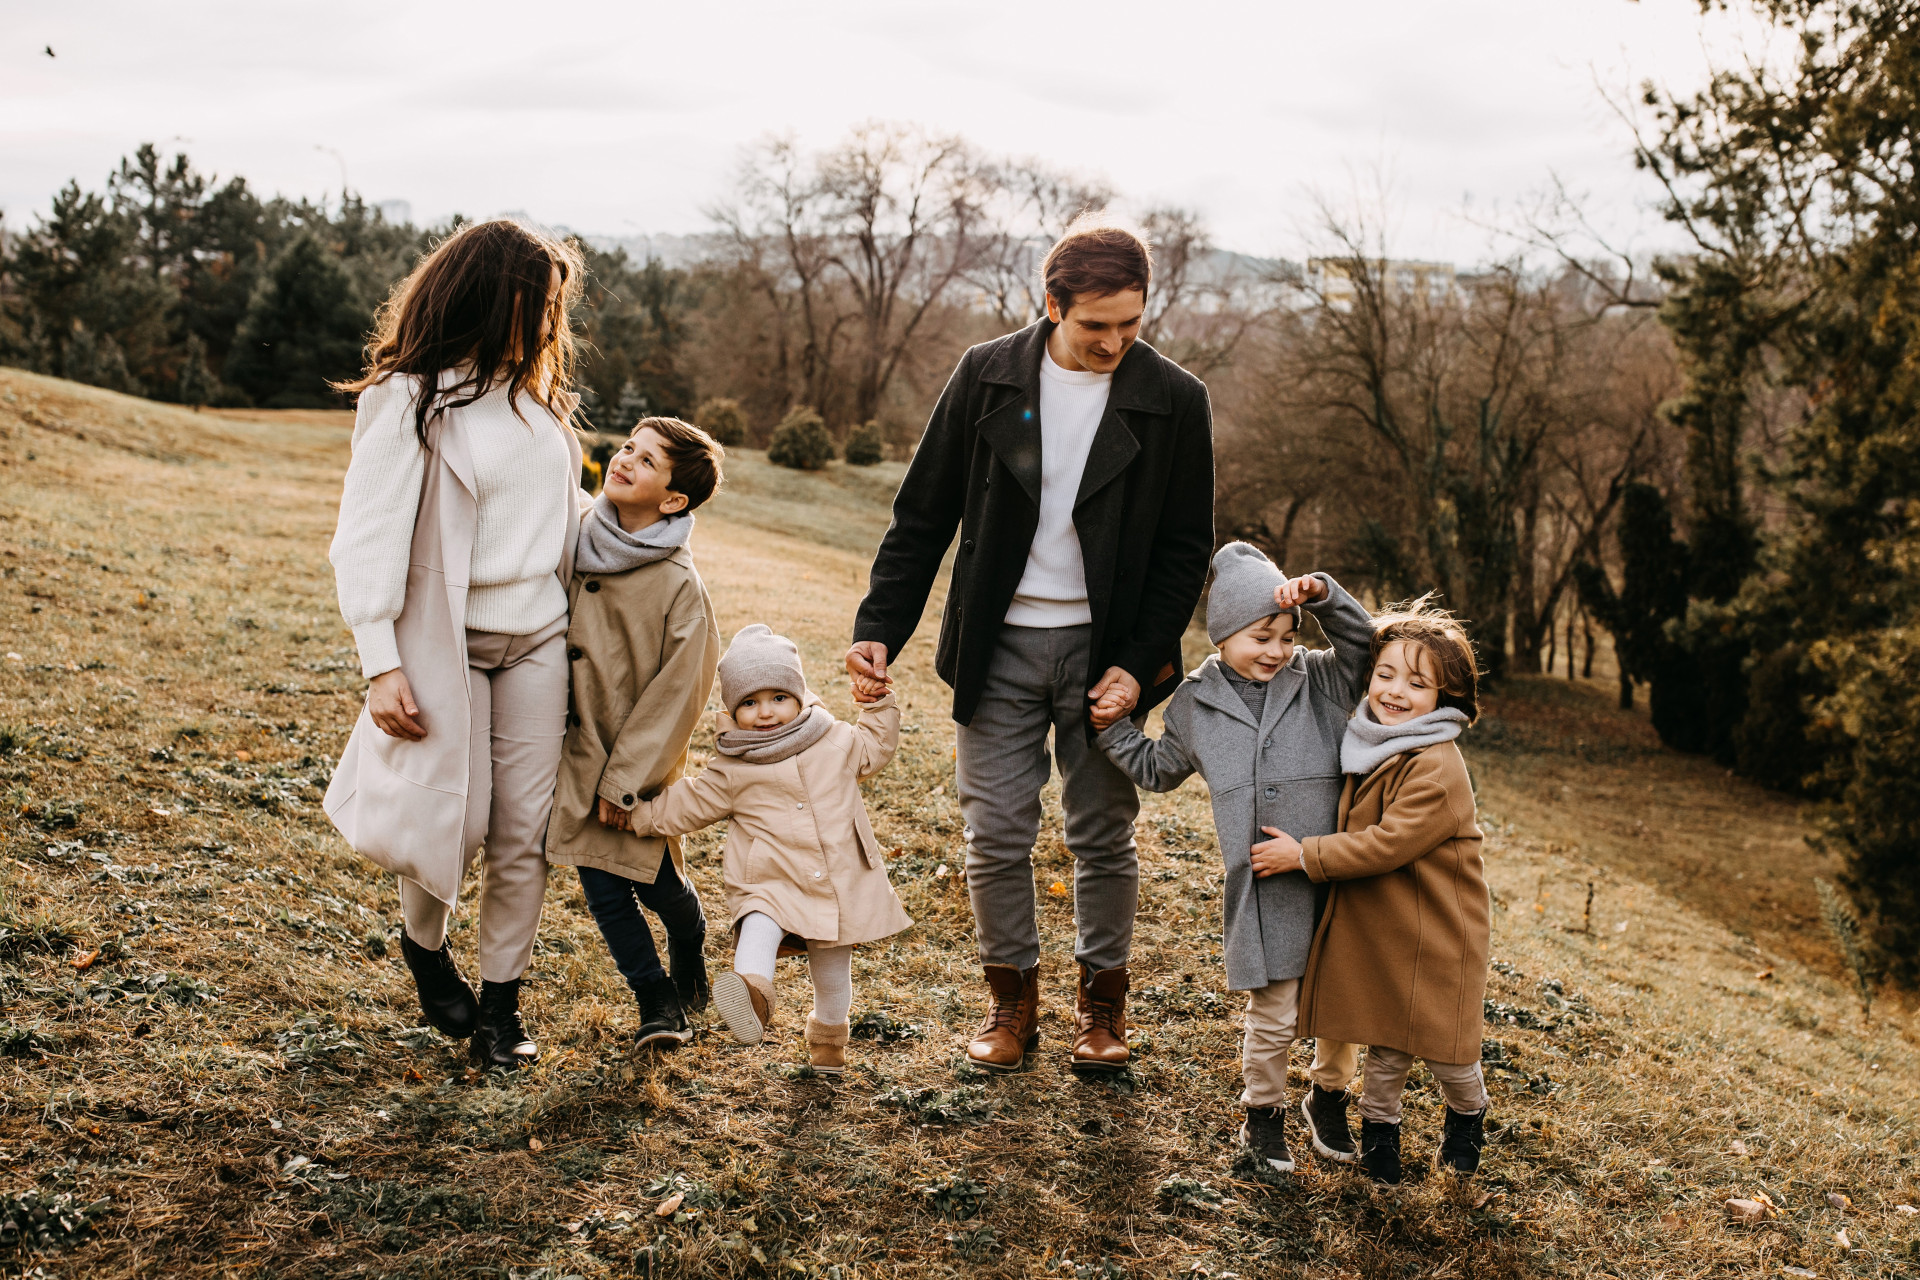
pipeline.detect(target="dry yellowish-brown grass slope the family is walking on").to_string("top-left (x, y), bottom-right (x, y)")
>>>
top-left (0, 370), bottom-right (1920, 1280)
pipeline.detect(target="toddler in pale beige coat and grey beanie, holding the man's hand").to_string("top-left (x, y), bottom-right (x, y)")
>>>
top-left (632, 624), bottom-right (914, 1075)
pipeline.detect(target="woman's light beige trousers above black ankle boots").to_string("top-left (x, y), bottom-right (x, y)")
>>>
top-left (399, 618), bottom-right (566, 983)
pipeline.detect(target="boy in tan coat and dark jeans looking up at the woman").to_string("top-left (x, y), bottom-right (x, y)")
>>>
top-left (547, 418), bottom-right (722, 1046)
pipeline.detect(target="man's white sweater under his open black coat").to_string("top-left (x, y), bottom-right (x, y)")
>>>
top-left (1006, 351), bottom-right (1114, 628)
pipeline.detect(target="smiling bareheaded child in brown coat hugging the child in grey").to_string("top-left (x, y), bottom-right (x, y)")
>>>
top-left (1256, 601), bottom-right (1490, 1182)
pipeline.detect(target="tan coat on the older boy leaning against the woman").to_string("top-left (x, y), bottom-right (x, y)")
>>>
top-left (547, 547), bottom-right (720, 885)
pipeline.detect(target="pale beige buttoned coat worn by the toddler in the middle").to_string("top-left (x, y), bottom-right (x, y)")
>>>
top-left (632, 693), bottom-right (914, 946)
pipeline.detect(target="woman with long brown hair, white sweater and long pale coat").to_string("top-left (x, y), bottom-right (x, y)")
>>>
top-left (326, 221), bottom-right (589, 1067)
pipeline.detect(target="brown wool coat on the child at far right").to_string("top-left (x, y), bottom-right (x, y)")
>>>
top-left (1300, 743), bottom-right (1492, 1063)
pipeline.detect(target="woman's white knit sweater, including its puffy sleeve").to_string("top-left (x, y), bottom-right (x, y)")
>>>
top-left (326, 376), bottom-right (578, 679)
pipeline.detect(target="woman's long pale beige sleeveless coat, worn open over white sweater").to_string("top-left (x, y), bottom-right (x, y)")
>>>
top-left (323, 395), bottom-right (586, 906)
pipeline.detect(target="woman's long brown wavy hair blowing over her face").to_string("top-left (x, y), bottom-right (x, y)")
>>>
top-left (336, 219), bottom-right (586, 449)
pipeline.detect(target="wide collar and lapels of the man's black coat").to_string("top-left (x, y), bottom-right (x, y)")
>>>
top-left (979, 319), bottom-right (1173, 507)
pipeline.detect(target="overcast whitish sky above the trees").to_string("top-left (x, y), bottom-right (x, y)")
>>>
top-left (0, 0), bottom-right (1757, 261)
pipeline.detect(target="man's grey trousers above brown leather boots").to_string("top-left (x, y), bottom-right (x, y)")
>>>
top-left (954, 626), bottom-right (1140, 969)
